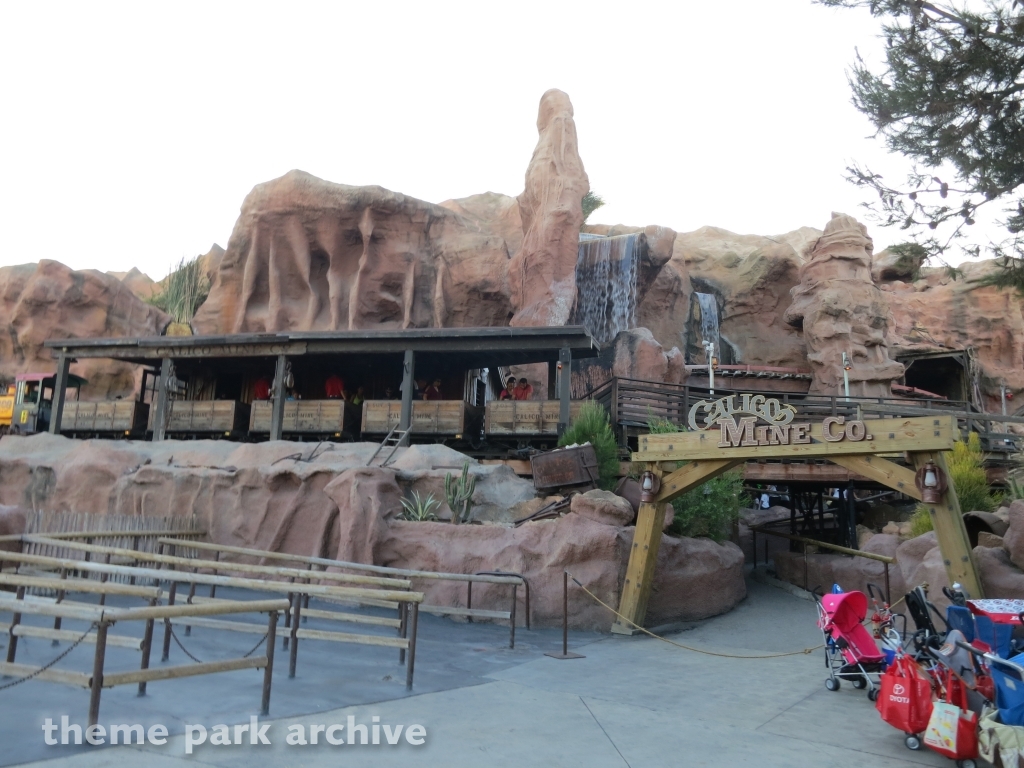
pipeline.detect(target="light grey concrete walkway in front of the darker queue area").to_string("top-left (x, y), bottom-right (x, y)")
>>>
top-left (0, 583), bottom-right (952, 768)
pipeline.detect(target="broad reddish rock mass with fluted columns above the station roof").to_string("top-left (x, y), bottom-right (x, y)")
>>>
top-left (193, 171), bottom-right (510, 333)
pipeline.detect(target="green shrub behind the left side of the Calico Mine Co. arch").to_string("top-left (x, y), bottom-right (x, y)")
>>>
top-left (647, 416), bottom-right (748, 543)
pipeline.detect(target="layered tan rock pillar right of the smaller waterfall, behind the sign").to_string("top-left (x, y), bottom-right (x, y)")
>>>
top-left (784, 213), bottom-right (903, 397)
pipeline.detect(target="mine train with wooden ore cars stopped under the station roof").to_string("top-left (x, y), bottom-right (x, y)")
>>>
top-left (0, 371), bottom-right (580, 454)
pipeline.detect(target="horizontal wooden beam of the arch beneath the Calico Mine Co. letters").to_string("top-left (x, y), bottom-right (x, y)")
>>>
top-left (633, 416), bottom-right (959, 462)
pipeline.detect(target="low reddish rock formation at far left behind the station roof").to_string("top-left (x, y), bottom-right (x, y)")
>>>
top-left (0, 259), bottom-right (170, 398)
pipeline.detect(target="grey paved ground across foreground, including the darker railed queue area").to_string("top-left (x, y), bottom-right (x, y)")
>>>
top-left (0, 583), bottom-right (952, 768)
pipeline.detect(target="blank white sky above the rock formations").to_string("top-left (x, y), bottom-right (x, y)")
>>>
top-left (0, 0), bottom-right (974, 278)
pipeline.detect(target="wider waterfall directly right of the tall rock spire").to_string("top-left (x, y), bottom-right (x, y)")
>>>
top-left (571, 234), bottom-right (642, 344)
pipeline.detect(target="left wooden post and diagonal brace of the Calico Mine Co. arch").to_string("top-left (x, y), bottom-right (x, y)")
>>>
top-left (611, 459), bottom-right (740, 635)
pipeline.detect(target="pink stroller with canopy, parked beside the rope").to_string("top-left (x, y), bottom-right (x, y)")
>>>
top-left (817, 592), bottom-right (886, 701)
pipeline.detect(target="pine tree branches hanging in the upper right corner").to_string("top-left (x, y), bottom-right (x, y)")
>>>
top-left (814, 0), bottom-right (1024, 290)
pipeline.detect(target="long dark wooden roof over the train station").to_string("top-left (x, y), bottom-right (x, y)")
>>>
top-left (44, 326), bottom-right (601, 370)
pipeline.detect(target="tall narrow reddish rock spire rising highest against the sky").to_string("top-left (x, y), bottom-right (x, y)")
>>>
top-left (509, 90), bottom-right (590, 326)
